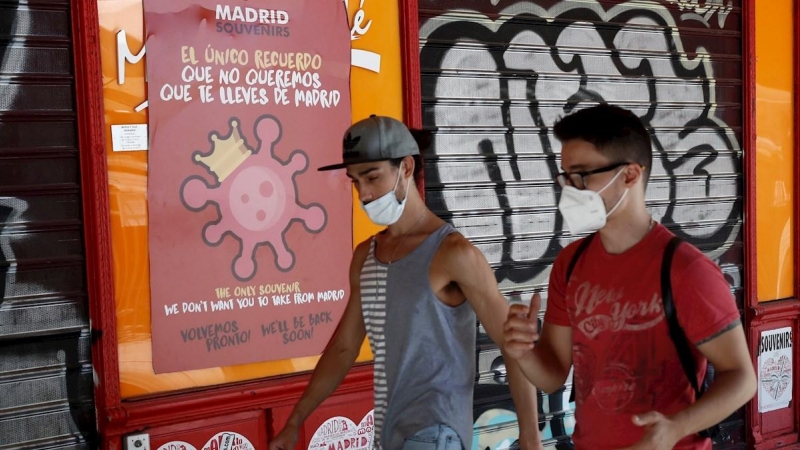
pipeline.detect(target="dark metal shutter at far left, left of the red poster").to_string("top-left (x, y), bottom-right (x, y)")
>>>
top-left (0, 0), bottom-right (96, 450)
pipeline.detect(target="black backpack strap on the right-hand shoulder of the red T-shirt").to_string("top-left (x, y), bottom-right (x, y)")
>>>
top-left (661, 236), bottom-right (704, 399)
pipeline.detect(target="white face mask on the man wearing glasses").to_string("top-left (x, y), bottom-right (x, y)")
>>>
top-left (558, 169), bottom-right (628, 235)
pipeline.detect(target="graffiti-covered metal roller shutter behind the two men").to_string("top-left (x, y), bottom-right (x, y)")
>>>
top-left (419, 0), bottom-right (744, 449)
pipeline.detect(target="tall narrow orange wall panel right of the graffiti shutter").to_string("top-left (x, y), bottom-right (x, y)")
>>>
top-left (750, 0), bottom-right (796, 301)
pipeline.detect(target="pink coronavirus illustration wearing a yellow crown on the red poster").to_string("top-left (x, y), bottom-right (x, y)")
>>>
top-left (181, 115), bottom-right (327, 281)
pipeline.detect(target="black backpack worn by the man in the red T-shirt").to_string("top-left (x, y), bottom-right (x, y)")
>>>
top-left (566, 234), bottom-right (720, 439)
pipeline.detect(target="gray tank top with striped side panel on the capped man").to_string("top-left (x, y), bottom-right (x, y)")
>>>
top-left (361, 224), bottom-right (476, 450)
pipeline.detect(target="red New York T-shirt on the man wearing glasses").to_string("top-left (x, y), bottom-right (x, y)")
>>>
top-left (545, 224), bottom-right (739, 450)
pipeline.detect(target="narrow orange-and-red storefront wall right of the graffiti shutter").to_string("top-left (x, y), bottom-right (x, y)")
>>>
top-left (746, 0), bottom-right (800, 449)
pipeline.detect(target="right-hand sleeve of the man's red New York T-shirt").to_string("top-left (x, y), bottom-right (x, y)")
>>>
top-left (672, 244), bottom-right (740, 344)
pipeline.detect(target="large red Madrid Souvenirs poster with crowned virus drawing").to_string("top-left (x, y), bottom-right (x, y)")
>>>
top-left (144, 0), bottom-right (352, 373)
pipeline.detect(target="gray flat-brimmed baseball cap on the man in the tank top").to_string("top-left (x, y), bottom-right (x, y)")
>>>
top-left (317, 114), bottom-right (419, 171)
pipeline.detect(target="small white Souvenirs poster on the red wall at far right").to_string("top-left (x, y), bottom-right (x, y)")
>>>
top-left (758, 327), bottom-right (794, 413)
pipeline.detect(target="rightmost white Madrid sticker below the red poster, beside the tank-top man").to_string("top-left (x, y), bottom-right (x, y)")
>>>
top-left (308, 411), bottom-right (375, 450)
